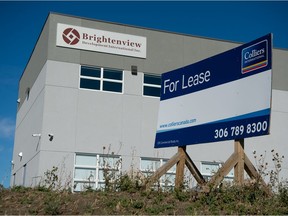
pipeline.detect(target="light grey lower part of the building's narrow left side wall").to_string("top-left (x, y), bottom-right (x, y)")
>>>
top-left (11, 62), bottom-right (46, 186)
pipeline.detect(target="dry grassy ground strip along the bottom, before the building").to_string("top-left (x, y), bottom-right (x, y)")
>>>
top-left (0, 185), bottom-right (288, 215)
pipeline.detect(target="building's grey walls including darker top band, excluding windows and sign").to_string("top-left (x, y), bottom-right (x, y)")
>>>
top-left (11, 14), bottom-right (288, 186)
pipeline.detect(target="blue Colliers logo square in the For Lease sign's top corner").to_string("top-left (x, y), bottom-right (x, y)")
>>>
top-left (242, 40), bottom-right (268, 74)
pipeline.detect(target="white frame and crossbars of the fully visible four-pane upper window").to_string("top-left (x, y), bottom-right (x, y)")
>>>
top-left (78, 65), bottom-right (124, 94)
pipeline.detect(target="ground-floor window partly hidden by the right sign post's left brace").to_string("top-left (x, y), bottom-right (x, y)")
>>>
top-left (201, 161), bottom-right (234, 180)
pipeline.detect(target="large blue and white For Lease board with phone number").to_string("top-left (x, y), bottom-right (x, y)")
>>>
top-left (155, 34), bottom-right (272, 148)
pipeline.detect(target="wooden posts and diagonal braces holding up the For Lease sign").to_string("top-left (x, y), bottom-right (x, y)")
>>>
top-left (144, 139), bottom-right (271, 195)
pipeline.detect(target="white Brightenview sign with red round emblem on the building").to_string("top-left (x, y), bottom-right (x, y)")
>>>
top-left (56, 23), bottom-right (146, 58)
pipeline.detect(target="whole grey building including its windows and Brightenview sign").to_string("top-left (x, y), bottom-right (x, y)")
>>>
top-left (11, 13), bottom-right (288, 191)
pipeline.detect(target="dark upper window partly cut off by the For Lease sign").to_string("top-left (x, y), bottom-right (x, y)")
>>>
top-left (143, 74), bottom-right (161, 97)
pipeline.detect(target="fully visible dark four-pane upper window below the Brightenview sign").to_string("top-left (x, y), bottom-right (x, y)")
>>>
top-left (80, 66), bottom-right (123, 93)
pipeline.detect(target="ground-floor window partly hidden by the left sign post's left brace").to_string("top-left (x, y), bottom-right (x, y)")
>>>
top-left (140, 158), bottom-right (176, 189)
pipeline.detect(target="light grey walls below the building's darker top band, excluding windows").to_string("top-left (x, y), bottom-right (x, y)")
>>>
top-left (11, 57), bottom-right (288, 186)
